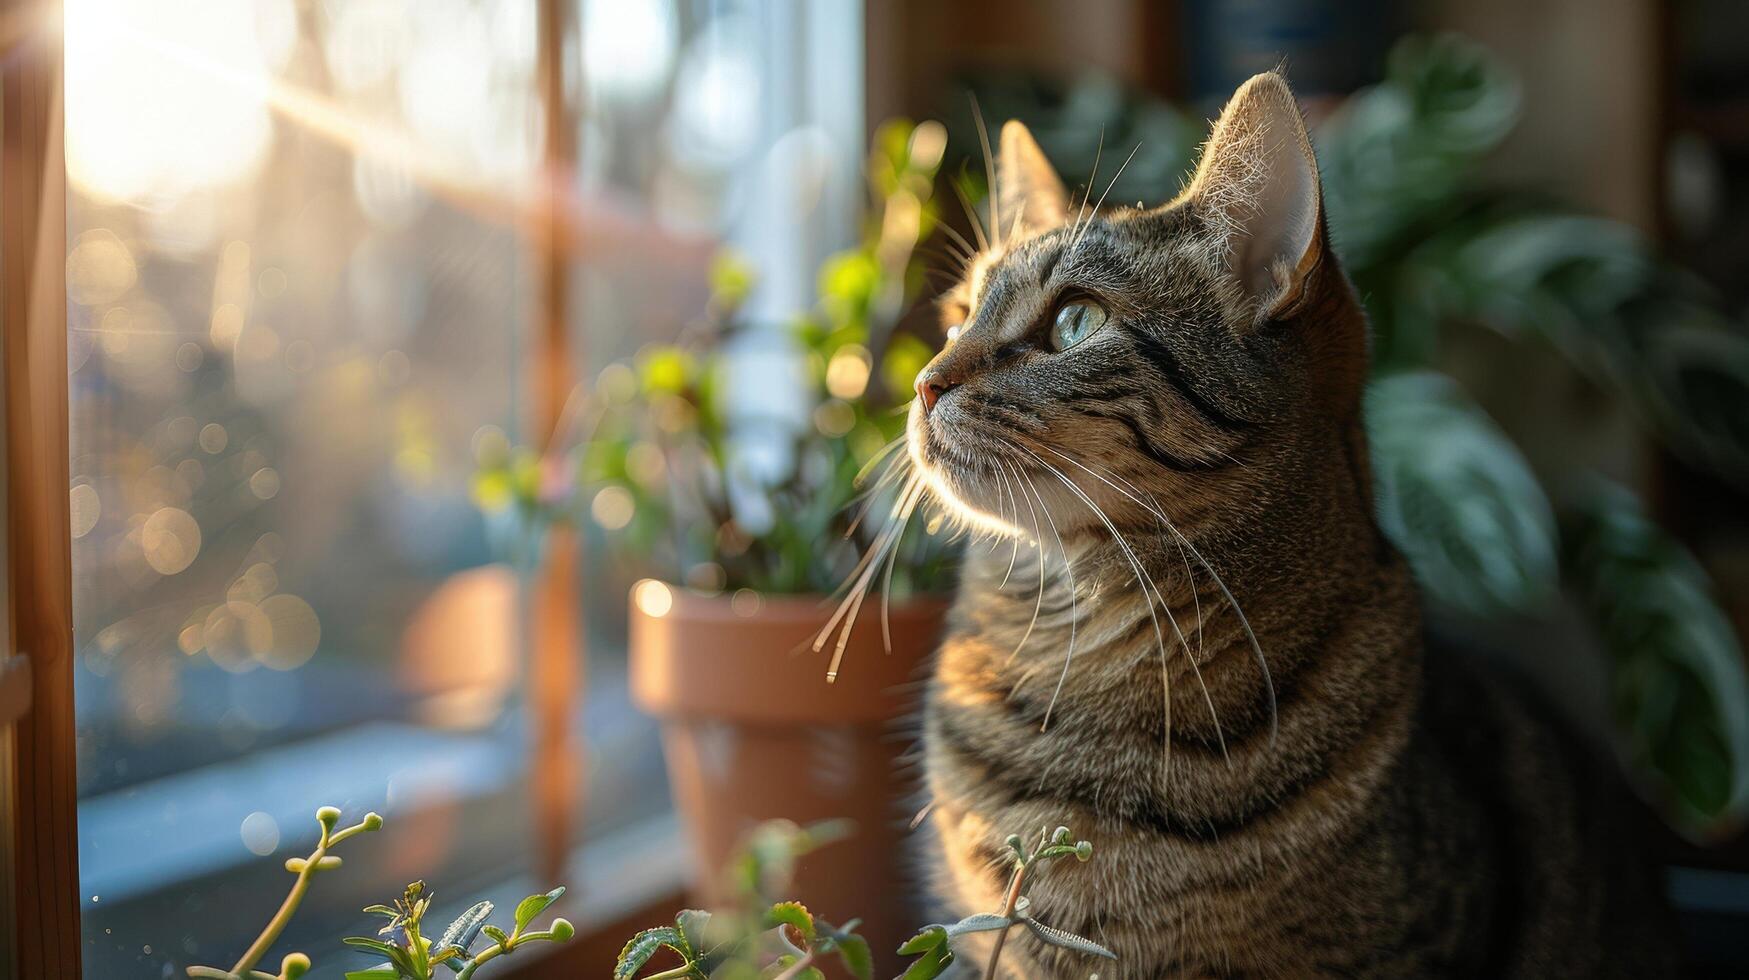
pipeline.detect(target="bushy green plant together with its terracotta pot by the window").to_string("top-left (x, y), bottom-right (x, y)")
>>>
top-left (476, 121), bottom-right (951, 945)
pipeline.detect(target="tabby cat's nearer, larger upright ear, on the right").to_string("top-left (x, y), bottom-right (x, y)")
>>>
top-left (1186, 72), bottom-right (1326, 317)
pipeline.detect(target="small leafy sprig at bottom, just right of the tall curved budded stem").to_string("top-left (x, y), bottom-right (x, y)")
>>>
top-left (343, 882), bottom-right (577, 980)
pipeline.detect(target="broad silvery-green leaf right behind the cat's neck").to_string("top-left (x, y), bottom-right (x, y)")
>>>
top-left (1366, 371), bottom-right (1558, 616)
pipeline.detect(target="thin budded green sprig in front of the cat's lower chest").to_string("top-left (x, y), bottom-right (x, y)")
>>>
top-left (899, 826), bottom-right (1118, 980)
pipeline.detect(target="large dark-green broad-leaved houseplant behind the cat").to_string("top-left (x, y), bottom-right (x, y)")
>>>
top-left (950, 37), bottom-right (1749, 837)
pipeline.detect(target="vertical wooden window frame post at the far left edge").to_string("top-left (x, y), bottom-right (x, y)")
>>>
top-left (0, 0), bottom-right (80, 980)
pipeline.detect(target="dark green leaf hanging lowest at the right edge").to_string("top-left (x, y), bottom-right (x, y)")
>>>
top-left (1565, 485), bottom-right (1749, 835)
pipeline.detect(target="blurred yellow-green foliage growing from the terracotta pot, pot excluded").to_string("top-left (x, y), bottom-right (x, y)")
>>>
top-left (474, 121), bottom-right (948, 595)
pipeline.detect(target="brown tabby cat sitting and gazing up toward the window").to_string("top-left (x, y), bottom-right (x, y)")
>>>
top-left (906, 72), bottom-right (1674, 980)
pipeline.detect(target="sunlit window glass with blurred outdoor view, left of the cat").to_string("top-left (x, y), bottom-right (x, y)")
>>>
top-left (65, 0), bottom-right (862, 977)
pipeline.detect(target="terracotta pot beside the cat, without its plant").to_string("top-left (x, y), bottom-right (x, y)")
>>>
top-left (631, 581), bottom-right (946, 964)
